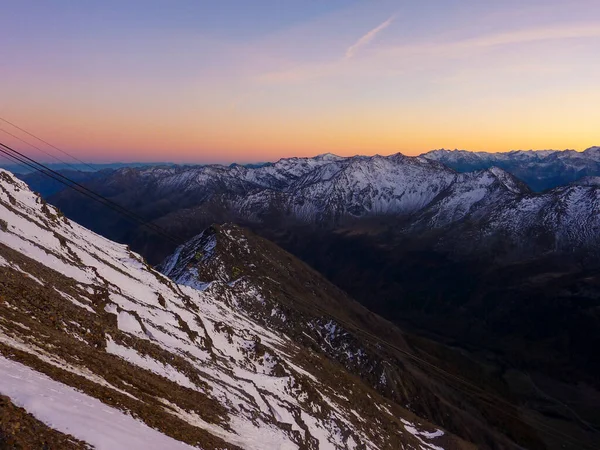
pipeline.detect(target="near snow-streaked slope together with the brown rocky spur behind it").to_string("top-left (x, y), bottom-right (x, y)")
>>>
top-left (0, 171), bottom-right (564, 450)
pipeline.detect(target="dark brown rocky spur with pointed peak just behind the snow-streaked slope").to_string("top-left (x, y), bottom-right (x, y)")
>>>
top-left (161, 225), bottom-right (552, 448)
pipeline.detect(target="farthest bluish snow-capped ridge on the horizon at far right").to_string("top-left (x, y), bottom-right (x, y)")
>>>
top-left (422, 147), bottom-right (600, 191)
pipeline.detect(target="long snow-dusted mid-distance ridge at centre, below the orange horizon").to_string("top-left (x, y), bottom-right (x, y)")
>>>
top-left (108, 154), bottom-right (456, 222)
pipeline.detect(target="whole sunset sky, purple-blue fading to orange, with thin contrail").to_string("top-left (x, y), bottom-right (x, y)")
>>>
top-left (0, 0), bottom-right (600, 163)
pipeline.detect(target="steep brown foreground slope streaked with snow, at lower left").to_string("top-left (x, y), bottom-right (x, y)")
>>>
top-left (0, 171), bottom-right (476, 449)
